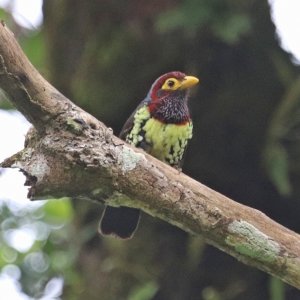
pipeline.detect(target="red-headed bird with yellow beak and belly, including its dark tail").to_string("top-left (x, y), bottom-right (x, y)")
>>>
top-left (99, 71), bottom-right (199, 239)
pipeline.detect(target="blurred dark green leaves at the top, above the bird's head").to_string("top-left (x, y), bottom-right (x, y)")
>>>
top-left (156, 0), bottom-right (251, 44)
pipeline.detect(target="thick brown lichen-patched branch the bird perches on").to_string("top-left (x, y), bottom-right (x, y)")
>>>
top-left (0, 24), bottom-right (300, 288)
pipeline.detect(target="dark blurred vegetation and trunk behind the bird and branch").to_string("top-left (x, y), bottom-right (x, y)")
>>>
top-left (0, 0), bottom-right (300, 300)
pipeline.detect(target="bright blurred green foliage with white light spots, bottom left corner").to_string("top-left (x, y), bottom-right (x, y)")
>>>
top-left (0, 200), bottom-right (78, 299)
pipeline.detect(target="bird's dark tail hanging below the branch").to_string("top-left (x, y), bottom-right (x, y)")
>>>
top-left (99, 206), bottom-right (140, 239)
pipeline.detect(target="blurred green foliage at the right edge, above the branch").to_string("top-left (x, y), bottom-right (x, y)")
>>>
top-left (264, 77), bottom-right (300, 196)
